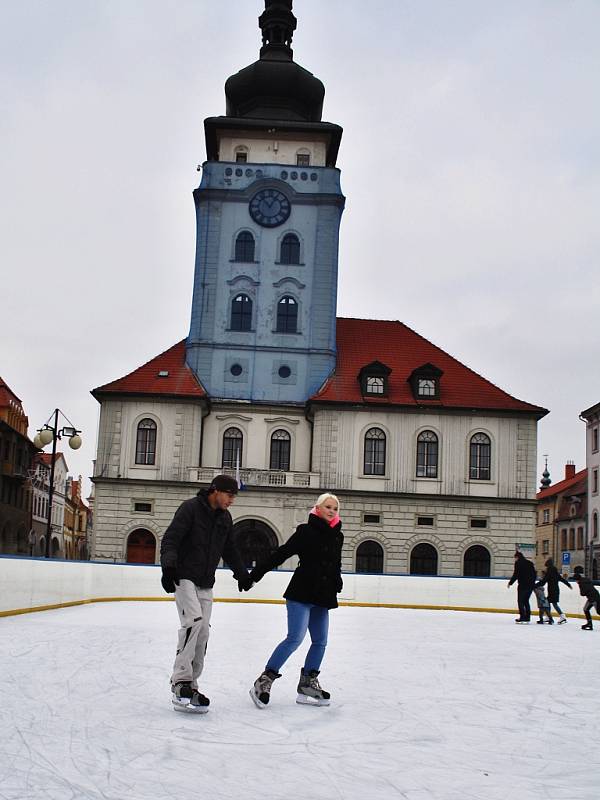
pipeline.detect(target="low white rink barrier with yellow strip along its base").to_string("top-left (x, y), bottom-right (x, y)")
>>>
top-left (0, 556), bottom-right (584, 619)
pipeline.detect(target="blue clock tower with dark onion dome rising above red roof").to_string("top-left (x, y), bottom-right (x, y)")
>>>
top-left (186, 0), bottom-right (344, 404)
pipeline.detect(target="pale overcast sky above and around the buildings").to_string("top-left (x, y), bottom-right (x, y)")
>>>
top-left (0, 0), bottom-right (600, 500)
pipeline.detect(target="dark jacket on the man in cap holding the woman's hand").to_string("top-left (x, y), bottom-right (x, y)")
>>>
top-left (160, 490), bottom-right (247, 589)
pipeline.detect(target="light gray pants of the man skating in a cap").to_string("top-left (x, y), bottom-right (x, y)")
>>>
top-left (171, 579), bottom-right (213, 689)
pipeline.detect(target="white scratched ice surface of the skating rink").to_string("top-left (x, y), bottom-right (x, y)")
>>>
top-left (0, 602), bottom-right (600, 800)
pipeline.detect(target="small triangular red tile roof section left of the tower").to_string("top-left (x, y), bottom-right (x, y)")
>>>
top-left (92, 339), bottom-right (206, 399)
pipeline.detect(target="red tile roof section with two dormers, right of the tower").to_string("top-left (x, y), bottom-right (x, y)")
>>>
top-left (312, 318), bottom-right (548, 418)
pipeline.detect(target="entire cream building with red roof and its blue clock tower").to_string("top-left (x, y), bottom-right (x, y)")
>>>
top-left (92, 0), bottom-right (547, 576)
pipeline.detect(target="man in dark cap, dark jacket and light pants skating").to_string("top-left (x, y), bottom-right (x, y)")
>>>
top-left (160, 475), bottom-right (252, 713)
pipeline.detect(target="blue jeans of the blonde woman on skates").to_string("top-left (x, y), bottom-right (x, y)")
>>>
top-left (265, 600), bottom-right (329, 672)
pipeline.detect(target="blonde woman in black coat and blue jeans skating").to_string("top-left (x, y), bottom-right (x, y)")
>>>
top-left (250, 492), bottom-right (344, 708)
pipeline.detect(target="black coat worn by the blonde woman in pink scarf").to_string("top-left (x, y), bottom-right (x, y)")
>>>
top-left (250, 514), bottom-right (344, 608)
